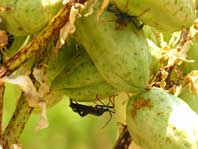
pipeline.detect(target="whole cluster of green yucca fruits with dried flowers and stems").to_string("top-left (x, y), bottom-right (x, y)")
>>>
top-left (0, 0), bottom-right (198, 149)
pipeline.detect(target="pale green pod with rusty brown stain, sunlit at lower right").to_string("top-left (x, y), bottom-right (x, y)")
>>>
top-left (126, 88), bottom-right (198, 149)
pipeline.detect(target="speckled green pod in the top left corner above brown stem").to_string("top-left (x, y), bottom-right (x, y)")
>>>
top-left (0, 0), bottom-right (62, 36)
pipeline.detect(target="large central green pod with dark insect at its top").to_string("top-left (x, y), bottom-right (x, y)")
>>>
top-left (76, 3), bottom-right (151, 92)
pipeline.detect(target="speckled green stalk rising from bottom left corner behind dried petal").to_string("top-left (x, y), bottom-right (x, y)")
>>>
top-left (3, 25), bottom-right (65, 149)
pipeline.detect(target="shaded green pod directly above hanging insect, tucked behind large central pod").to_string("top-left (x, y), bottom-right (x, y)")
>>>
top-left (51, 46), bottom-right (118, 101)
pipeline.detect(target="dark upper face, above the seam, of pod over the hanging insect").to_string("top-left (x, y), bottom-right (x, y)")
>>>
top-left (52, 51), bottom-right (103, 90)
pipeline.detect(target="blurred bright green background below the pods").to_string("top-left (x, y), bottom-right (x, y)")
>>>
top-left (3, 84), bottom-right (120, 149)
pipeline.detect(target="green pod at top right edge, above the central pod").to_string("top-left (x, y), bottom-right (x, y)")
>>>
top-left (112, 0), bottom-right (196, 32)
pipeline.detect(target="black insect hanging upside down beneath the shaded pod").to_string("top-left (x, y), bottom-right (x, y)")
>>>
top-left (69, 98), bottom-right (115, 125)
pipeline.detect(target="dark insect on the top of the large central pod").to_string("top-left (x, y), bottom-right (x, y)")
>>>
top-left (107, 4), bottom-right (144, 30)
